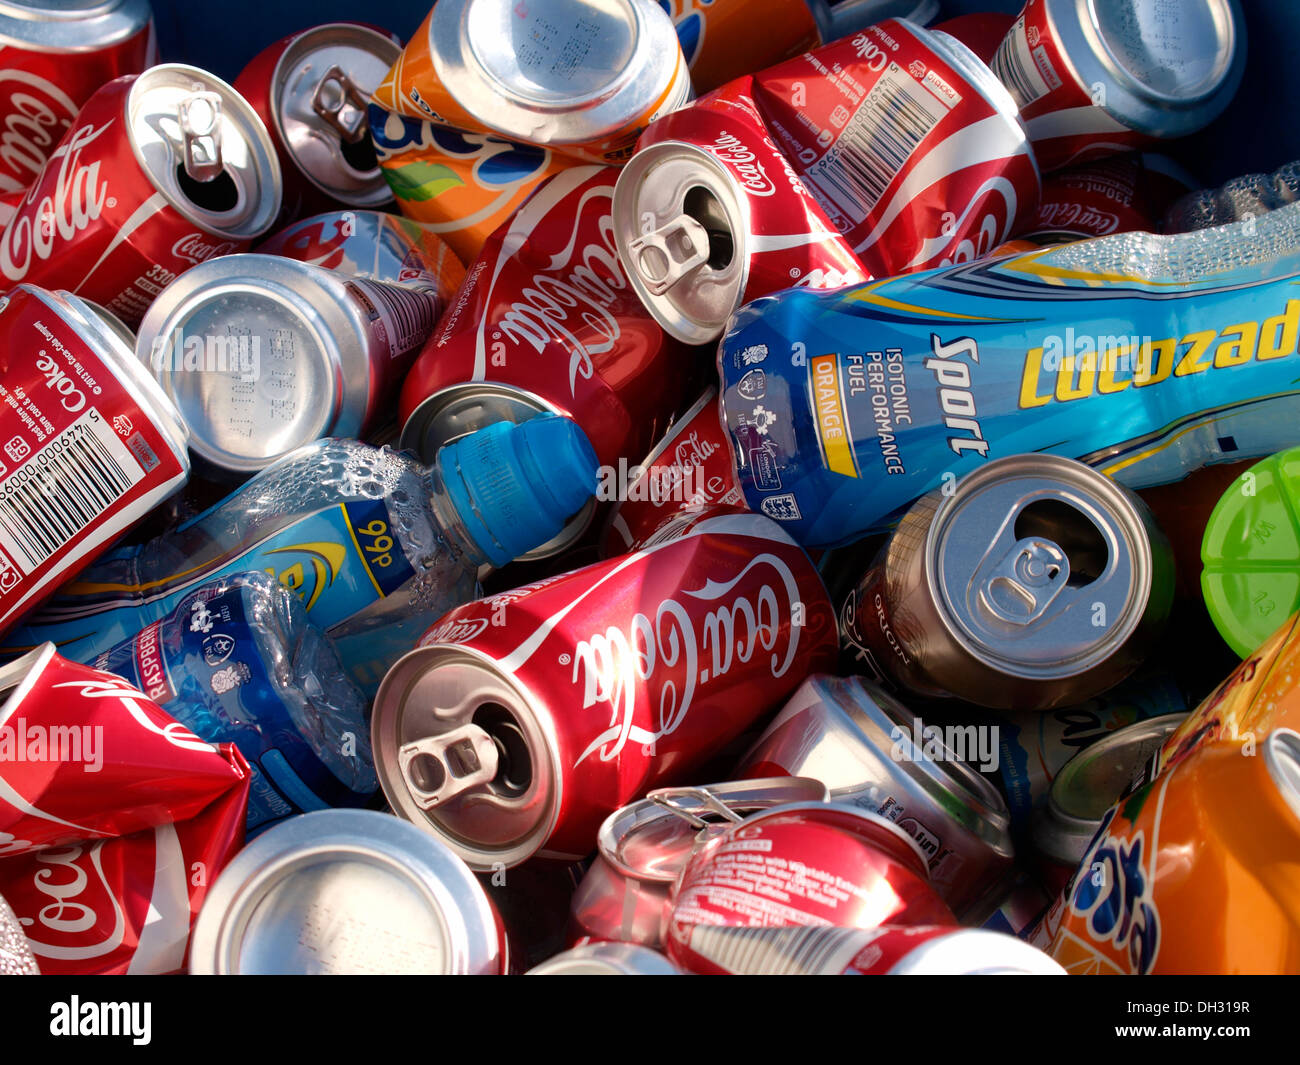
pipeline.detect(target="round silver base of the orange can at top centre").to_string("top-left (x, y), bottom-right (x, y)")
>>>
top-left (429, 0), bottom-right (689, 147)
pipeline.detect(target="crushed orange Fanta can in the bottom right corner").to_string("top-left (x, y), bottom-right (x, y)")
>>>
top-left (1034, 614), bottom-right (1300, 974)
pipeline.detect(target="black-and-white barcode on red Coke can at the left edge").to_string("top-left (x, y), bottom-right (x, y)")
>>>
top-left (0, 407), bottom-right (144, 575)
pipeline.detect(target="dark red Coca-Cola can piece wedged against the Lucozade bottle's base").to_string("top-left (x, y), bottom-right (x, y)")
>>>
top-left (597, 386), bottom-right (745, 558)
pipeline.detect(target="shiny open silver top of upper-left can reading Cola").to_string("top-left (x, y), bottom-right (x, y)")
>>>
top-left (126, 62), bottom-right (283, 241)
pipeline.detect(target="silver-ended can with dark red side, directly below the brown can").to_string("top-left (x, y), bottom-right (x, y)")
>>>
top-left (738, 674), bottom-right (1014, 915)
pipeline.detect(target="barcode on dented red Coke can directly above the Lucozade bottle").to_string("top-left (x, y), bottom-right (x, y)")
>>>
top-left (803, 62), bottom-right (959, 225)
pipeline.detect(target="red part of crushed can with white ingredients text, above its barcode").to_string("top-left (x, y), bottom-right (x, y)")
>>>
top-left (667, 802), bottom-right (957, 973)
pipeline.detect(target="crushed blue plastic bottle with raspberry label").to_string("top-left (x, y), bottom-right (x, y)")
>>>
top-left (94, 571), bottom-right (380, 832)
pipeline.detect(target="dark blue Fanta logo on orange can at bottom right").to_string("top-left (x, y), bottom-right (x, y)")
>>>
top-left (1070, 809), bottom-right (1160, 975)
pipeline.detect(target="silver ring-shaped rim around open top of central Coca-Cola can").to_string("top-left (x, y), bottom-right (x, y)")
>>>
top-left (371, 644), bottom-right (564, 873)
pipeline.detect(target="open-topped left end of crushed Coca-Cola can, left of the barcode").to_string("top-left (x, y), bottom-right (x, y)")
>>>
top-left (614, 77), bottom-right (870, 343)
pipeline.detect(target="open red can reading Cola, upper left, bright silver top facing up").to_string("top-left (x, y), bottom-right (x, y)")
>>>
top-left (0, 64), bottom-right (281, 325)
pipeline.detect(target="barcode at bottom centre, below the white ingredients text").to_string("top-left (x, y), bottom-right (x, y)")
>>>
top-left (690, 925), bottom-right (872, 977)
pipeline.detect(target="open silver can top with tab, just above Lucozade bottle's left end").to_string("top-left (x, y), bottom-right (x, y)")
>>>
top-left (611, 140), bottom-right (750, 343)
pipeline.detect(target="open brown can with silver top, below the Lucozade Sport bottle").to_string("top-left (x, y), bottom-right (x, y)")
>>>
top-left (840, 454), bottom-right (1174, 710)
